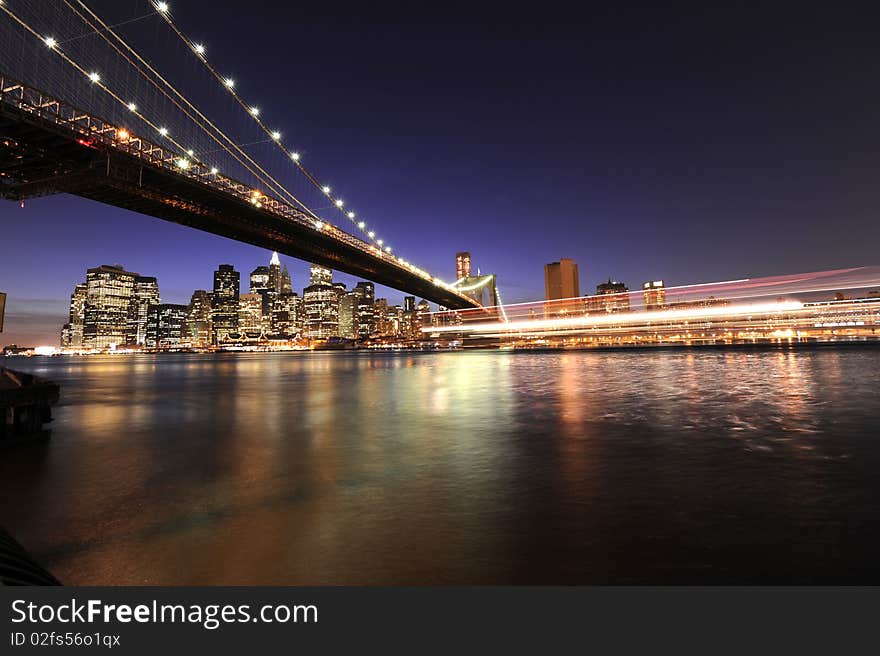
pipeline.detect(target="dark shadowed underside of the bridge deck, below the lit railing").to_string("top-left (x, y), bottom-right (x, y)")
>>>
top-left (0, 100), bottom-right (472, 309)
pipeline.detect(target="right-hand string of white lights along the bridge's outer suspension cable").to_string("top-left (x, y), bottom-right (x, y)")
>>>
top-left (151, 0), bottom-right (412, 266)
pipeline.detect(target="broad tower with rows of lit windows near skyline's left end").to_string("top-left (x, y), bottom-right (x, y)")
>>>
top-left (83, 264), bottom-right (138, 349)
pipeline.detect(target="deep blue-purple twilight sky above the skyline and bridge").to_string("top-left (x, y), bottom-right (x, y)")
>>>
top-left (0, 0), bottom-right (880, 344)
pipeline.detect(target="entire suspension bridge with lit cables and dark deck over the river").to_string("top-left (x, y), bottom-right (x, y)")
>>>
top-left (0, 0), bottom-right (481, 309)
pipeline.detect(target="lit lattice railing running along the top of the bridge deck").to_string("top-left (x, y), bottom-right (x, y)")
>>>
top-left (0, 74), bottom-right (474, 304)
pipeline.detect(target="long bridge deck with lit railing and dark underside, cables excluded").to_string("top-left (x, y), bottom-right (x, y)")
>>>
top-left (0, 76), bottom-right (477, 309)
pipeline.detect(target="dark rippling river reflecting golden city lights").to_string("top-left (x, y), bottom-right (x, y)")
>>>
top-left (0, 349), bottom-right (880, 584)
